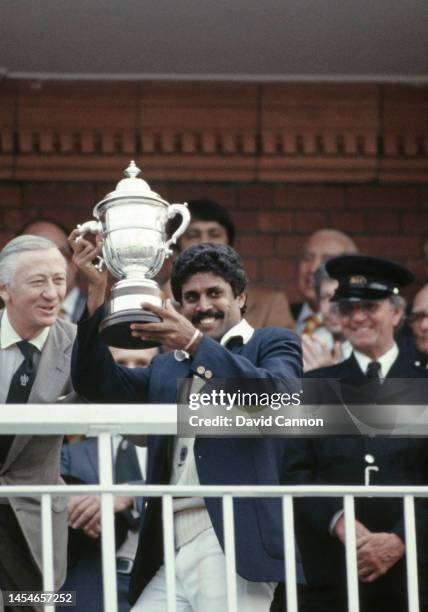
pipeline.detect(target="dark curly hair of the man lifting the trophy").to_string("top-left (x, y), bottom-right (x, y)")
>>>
top-left (171, 242), bottom-right (248, 304)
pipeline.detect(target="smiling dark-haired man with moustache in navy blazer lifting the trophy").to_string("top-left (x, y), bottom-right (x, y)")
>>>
top-left (71, 239), bottom-right (302, 612)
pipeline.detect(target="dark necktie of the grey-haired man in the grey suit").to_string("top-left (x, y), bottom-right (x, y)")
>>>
top-left (0, 340), bottom-right (37, 463)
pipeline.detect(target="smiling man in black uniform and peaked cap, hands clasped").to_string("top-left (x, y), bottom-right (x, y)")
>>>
top-left (284, 255), bottom-right (428, 612)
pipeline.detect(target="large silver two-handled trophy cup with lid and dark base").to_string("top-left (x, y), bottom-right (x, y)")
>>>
top-left (77, 161), bottom-right (190, 348)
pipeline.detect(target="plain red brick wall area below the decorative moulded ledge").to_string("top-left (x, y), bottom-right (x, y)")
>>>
top-left (0, 177), bottom-right (428, 299)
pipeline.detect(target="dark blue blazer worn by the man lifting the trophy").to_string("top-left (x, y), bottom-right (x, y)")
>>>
top-left (72, 309), bottom-right (302, 602)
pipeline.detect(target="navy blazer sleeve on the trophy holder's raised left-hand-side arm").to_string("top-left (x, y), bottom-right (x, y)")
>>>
top-left (71, 306), bottom-right (151, 403)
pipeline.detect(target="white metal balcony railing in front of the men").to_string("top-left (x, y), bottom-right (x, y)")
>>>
top-left (0, 404), bottom-right (428, 612)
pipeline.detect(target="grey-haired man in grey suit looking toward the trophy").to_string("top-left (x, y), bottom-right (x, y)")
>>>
top-left (0, 236), bottom-right (75, 610)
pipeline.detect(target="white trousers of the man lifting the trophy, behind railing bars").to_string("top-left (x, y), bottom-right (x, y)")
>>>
top-left (131, 527), bottom-right (277, 612)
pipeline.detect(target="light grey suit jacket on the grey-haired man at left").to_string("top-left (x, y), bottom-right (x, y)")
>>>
top-left (0, 313), bottom-right (77, 590)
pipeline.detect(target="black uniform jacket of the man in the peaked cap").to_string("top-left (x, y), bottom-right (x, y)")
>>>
top-left (283, 354), bottom-right (428, 595)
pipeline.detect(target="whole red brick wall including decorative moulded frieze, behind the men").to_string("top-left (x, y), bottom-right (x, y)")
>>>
top-left (0, 78), bottom-right (428, 299)
